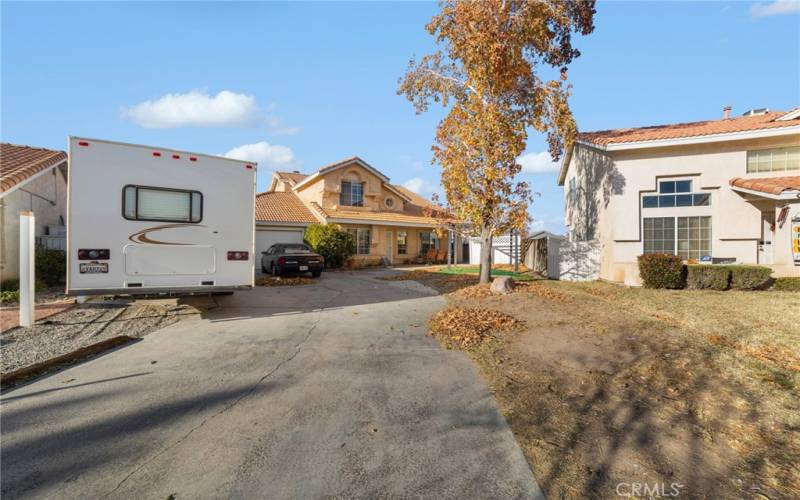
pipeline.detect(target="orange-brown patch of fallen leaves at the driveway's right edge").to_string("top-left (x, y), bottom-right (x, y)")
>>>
top-left (429, 307), bottom-right (524, 349)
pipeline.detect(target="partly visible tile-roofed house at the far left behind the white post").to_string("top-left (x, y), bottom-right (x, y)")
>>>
top-left (0, 143), bottom-right (67, 280)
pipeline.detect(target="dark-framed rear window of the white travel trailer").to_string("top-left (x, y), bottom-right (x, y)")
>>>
top-left (122, 185), bottom-right (203, 223)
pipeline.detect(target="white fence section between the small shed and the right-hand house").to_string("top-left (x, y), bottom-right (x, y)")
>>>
top-left (547, 240), bottom-right (600, 281)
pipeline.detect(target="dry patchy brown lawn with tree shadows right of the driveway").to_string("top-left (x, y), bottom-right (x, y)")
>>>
top-left (398, 271), bottom-right (800, 499)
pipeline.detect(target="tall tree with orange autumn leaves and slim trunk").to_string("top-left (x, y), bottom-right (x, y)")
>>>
top-left (398, 0), bottom-right (595, 283)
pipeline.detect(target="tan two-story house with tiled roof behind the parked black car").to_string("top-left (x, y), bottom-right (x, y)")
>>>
top-left (250, 157), bottom-right (468, 267)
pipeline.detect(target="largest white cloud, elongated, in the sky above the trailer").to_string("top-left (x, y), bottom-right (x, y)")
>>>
top-left (122, 90), bottom-right (258, 129)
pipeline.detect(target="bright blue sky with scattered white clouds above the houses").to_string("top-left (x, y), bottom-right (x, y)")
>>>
top-left (0, 0), bottom-right (800, 231)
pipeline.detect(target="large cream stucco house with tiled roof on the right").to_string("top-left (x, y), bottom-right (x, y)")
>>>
top-left (558, 108), bottom-right (800, 285)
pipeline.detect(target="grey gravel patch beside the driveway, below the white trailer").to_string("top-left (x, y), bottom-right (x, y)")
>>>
top-left (0, 301), bottom-right (199, 373)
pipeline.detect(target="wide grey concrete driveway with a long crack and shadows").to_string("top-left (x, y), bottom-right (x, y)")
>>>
top-left (0, 272), bottom-right (541, 499)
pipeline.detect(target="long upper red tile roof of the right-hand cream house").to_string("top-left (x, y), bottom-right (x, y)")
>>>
top-left (578, 111), bottom-right (800, 146)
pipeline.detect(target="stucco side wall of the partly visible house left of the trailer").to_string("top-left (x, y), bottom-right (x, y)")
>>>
top-left (0, 167), bottom-right (67, 280)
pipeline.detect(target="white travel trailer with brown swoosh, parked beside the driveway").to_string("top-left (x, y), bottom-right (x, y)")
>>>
top-left (67, 137), bottom-right (256, 295)
